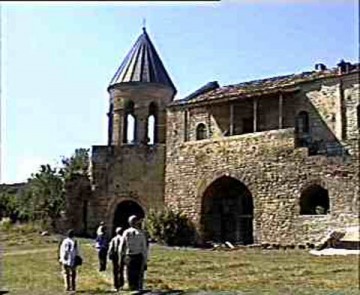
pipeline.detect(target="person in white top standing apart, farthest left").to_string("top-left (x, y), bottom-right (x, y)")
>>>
top-left (59, 229), bottom-right (79, 291)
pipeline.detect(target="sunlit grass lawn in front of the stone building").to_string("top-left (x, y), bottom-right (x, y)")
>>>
top-left (0, 225), bottom-right (360, 295)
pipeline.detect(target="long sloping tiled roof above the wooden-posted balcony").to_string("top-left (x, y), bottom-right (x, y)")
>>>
top-left (170, 63), bottom-right (360, 106)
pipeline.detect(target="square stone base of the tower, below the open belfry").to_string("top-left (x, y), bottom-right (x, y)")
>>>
top-left (88, 144), bottom-right (165, 236)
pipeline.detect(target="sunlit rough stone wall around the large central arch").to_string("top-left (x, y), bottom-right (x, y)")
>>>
top-left (165, 76), bottom-right (360, 243)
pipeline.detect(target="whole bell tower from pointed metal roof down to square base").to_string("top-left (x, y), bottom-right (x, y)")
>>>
top-left (92, 28), bottom-right (176, 231)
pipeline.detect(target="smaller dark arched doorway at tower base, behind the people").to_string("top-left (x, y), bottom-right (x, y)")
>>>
top-left (112, 200), bottom-right (145, 234)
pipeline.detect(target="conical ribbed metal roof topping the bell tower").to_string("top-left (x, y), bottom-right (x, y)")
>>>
top-left (109, 28), bottom-right (176, 92)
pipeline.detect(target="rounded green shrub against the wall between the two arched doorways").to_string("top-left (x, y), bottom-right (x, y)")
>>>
top-left (145, 208), bottom-right (195, 246)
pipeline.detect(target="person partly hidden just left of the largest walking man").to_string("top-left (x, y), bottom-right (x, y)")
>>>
top-left (108, 227), bottom-right (124, 291)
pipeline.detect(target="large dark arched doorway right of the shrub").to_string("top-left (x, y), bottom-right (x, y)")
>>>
top-left (201, 176), bottom-right (253, 245)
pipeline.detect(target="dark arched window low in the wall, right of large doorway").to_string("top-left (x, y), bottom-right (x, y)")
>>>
top-left (300, 184), bottom-right (330, 215)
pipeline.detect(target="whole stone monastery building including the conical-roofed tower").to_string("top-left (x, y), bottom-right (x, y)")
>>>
top-left (68, 29), bottom-right (360, 244)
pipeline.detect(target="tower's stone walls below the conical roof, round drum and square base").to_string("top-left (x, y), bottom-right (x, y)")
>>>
top-left (88, 82), bottom-right (174, 236)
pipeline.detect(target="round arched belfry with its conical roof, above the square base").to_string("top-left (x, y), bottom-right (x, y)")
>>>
top-left (108, 28), bottom-right (176, 147)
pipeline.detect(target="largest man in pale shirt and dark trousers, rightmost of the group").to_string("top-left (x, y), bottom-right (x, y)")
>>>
top-left (119, 215), bottom-right (148, 291)
